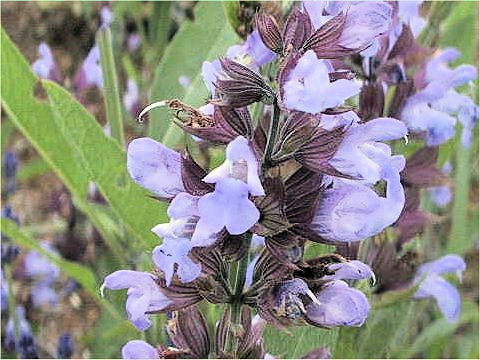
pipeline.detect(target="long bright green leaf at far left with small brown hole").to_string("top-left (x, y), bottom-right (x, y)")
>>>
top-left (2, 31), bottom-right (166, 253)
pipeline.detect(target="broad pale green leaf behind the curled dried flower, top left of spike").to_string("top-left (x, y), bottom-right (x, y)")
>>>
top-left (149, 2), bottom-right (238, 146)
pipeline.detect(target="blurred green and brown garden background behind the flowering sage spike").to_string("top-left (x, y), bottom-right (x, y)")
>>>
top-left (1, 1), bottom-right (479, 358)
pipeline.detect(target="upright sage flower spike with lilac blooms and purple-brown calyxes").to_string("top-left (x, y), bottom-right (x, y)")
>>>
top-left (102, 1), bottom-right (475, 358)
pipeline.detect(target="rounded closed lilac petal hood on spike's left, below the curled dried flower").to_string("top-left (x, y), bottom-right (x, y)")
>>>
top-left (127, 138), bottom-right (184, 198)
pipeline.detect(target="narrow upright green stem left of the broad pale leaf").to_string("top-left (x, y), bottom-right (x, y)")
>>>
top-left (98, 27), bottom-right (125, 148)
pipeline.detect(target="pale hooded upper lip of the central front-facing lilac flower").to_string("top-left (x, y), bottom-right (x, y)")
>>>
top-left (203, 136), bottom-right (265, 196)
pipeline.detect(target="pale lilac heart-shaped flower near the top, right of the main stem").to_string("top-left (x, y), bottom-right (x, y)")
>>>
top-left (283, 50), bottom-right (361, 114)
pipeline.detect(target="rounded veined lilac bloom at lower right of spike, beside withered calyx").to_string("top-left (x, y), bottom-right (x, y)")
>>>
top-left (306, 280), bottom-right (370, 327)
